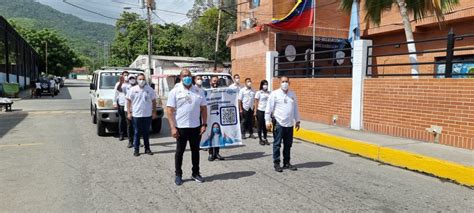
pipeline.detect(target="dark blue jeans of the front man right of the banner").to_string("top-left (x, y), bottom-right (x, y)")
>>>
top-left (273, 123), bottom-right (293, 164)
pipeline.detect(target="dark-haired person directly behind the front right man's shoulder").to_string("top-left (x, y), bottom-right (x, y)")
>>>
top-left (254, 80), bottom-right (270, 145)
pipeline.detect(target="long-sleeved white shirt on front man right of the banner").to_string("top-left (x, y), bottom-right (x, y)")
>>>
top-left (265, 89), bottom-right (300, 127)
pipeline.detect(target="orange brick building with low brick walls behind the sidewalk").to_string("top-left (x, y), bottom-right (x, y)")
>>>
top-left (227, 0), bottom-right (474, 150)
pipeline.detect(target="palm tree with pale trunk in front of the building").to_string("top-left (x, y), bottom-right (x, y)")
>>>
top-left (341, 0), bottom-right (459, 78)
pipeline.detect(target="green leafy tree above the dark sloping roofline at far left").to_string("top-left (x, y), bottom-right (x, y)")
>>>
top-left (12, 22), bottom-right (83, 76)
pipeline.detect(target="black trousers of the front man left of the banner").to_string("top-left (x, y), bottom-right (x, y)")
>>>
top-left (174, 127), bottom-right (201, 176)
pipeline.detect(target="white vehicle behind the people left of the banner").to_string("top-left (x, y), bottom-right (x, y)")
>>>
top-left (90, 67), bottom-right (163, 136)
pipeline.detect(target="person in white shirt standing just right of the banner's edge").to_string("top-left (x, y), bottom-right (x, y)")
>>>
top-left (239, 78), bottom-right (257, 139)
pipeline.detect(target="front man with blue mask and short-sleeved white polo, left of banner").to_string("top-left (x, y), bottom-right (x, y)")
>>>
top-left (166, 69), bottom-right (207, 186)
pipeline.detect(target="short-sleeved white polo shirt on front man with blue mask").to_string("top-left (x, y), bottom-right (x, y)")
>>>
top-left (166, 84), bottom-right (207, 128)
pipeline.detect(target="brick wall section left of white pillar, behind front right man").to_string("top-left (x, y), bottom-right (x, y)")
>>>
top-left (273, 78), bottom-right (352, 127)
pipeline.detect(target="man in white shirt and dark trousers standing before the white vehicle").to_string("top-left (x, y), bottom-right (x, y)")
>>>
top-left (127, 73), bottom-right (156, 156)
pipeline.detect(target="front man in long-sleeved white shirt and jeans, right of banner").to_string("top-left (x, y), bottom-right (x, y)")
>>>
top-left (265, 76), bottom-right (300, 172)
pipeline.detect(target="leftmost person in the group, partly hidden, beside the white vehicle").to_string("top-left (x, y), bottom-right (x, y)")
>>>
top-left (114, 71), bottom-right (128, 141)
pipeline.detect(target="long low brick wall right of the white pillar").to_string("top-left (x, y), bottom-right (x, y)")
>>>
top-left (364, 78), bottom-right (474, 149)
